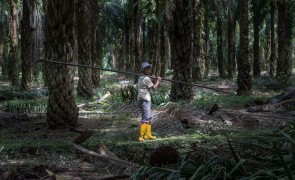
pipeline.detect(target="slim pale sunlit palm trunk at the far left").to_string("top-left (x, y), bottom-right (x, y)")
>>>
top-left (9, 0), bottom-right (19, 86)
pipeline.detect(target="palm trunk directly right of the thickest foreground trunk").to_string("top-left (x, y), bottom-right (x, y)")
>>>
top-left (77, 0), bottom-right (92, 98)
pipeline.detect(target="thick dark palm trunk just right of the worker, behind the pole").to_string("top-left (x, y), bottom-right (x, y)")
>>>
top-left (170, 0), bottom-right (193, 101)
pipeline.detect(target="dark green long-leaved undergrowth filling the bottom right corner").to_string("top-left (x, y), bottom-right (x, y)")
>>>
top-left (131, 126), bottom-right (295, 180)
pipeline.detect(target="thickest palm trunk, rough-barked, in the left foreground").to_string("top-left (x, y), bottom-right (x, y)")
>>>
top-left (45, 0), bottom-right (78, 128)
